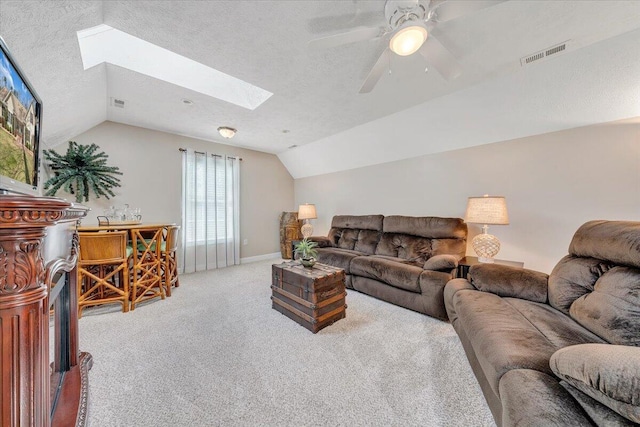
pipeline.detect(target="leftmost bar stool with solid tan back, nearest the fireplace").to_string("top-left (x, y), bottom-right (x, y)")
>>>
top-left (78, 231), bottom-right (129, 317)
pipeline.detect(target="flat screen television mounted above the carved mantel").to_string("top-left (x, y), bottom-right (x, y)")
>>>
top-left (0, 37), bottom-right (42, 194)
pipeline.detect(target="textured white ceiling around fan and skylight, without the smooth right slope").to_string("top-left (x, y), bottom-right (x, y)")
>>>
top-left (0, 0), bottom-right (640, 173)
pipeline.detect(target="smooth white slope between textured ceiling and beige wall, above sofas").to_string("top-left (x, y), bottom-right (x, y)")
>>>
top-left (278, 25), bottom-right (640, 179)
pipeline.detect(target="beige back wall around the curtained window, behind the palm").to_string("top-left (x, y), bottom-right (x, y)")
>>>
top-left (56, 122), bottom-right (294, 258)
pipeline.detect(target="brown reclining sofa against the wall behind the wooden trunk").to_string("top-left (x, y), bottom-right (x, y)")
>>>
top-left (312, 215), bottom-right (467, 319)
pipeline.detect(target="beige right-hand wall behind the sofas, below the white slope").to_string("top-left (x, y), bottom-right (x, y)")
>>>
top-left (295, 118), bottom-right (640, 272)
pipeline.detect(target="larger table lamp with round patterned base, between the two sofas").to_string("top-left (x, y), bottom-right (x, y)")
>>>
top-left (464, 194), bottom-right (509, 262)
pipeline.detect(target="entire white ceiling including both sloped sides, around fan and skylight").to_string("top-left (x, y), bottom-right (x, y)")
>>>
top-left (0, 0), bottom-right (640, 178)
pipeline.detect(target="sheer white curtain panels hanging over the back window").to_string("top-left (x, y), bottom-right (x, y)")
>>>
top-left (181, 149), bottom-right (240, 273)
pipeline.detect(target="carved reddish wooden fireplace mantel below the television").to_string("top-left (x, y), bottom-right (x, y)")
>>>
top-left (0, 194), bottom-right (92, 427)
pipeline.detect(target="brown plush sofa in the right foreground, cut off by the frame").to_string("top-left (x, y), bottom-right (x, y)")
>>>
top-left (445, 221), bottom-right (640, 426)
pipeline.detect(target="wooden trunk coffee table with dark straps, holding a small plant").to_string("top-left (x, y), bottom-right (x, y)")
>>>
top-left (271, 261), bottom-right (347, 334)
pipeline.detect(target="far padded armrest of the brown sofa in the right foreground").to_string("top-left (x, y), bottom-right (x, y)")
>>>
top-left (469, 264), bottom-right (549, 303)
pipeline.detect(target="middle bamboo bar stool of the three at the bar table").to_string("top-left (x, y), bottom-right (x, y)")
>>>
top-left (131, 227), bottom-right (165, 310)
